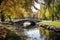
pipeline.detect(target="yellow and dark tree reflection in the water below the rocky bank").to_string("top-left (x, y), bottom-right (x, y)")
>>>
top-left (39, 28), bottom-right (57, 40)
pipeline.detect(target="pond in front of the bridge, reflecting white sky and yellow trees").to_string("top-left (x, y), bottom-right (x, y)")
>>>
top-left (17, 27), bottom-right (60, 40)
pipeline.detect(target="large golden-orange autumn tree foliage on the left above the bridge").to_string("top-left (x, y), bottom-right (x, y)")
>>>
top-left (0, 0), bottom-right (34, 19)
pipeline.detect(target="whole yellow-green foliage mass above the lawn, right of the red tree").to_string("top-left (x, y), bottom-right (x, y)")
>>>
top-left (41, 0), bottom-right (60, 20)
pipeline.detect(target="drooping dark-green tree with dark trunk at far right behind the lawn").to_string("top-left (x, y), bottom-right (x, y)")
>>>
top-left (44, 0), bottom-right (60, 21)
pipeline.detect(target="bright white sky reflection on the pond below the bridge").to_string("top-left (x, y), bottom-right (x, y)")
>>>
top-left (24, 28), bottom-right (46, 40)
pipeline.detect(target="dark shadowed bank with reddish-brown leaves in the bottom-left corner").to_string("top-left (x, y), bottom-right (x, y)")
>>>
top-left (0, 28), bottom-right (22, 40)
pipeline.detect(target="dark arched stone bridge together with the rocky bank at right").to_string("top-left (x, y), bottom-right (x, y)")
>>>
top-left (0, 19), bottom-right (60, 35)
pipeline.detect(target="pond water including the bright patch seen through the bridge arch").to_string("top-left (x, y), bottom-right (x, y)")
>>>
top-left (12, 21), bottom-right (60, 40)
